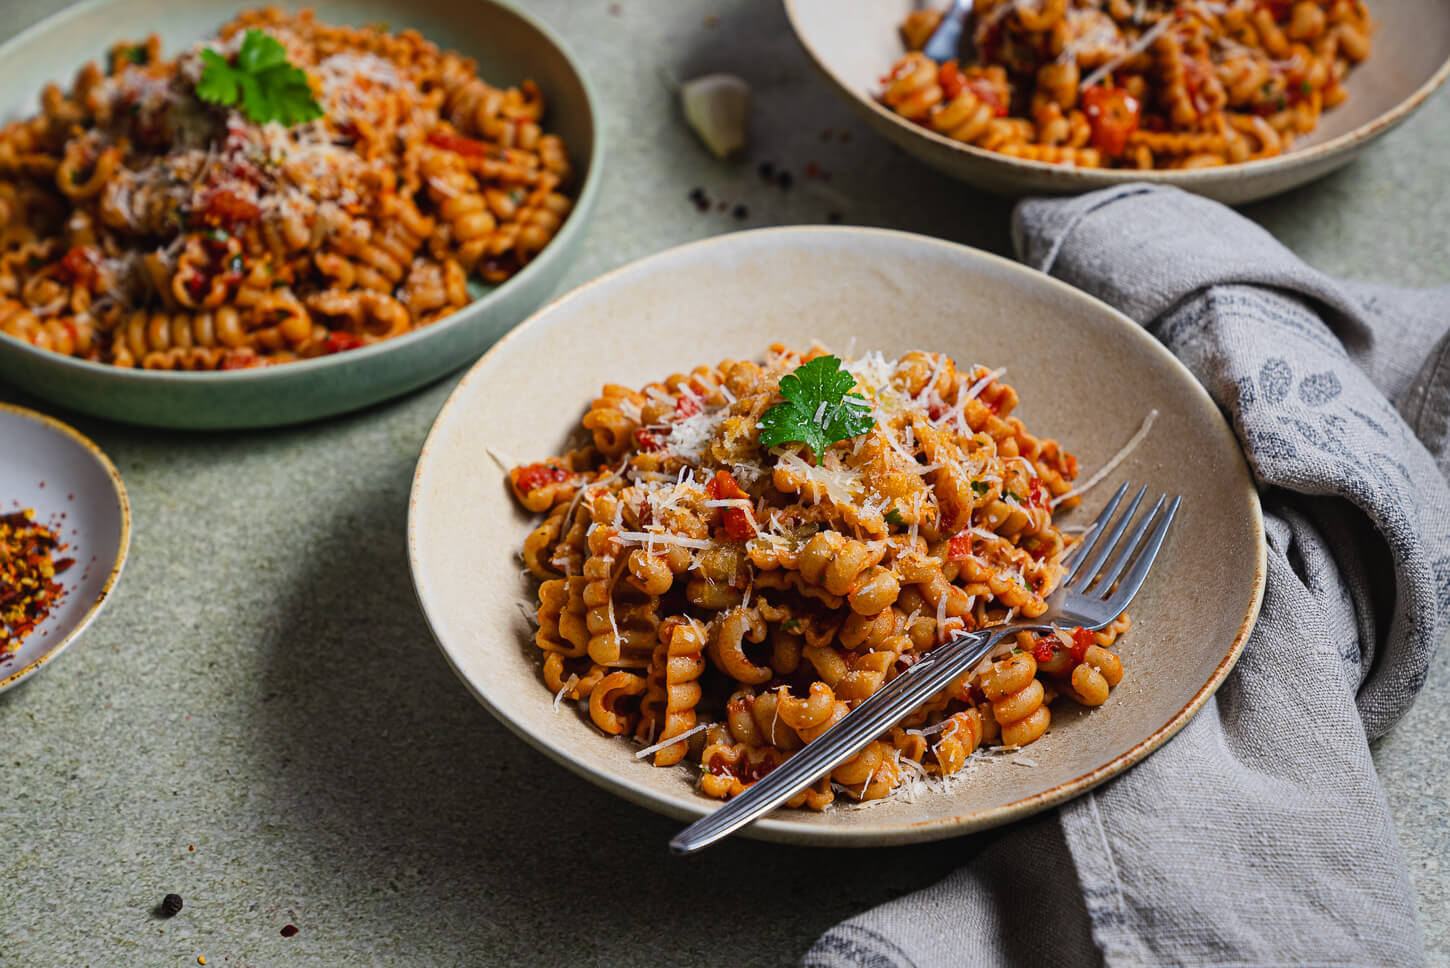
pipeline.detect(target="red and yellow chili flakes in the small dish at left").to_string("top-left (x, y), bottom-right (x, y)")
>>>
top-left (0, 509), bottom-right (75, 655)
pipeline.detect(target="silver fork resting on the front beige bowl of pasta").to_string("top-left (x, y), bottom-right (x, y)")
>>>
top-left (670, 484), bottom-right (1182, 854)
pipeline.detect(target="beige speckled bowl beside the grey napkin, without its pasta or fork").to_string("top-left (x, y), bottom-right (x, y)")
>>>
top-left (407, 228), bottom-right (1264, 848)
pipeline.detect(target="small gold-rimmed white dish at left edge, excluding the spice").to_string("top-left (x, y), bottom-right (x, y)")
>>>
top-left (0, 403), bottom-right (131, 693)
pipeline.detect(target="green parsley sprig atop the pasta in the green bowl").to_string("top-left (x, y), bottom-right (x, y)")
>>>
top-left (196, 30), bottom-right (322, 126)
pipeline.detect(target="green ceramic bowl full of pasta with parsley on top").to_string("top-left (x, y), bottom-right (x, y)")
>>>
top-left (0, 0), bottom-right (600, 427)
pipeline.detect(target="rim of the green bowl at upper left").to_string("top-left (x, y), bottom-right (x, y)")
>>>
top-left (0, 0), bottom-right (606, 387)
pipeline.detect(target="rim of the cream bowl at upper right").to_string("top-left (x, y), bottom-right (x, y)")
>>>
top-left (784, 0), bottom-right (1450, 191)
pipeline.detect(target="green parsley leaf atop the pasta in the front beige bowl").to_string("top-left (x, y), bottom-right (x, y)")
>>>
top-left (760, 356), bottom-right (876, 458)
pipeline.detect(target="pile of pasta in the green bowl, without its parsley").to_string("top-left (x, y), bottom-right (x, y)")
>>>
top-left (0, 9), bottom-right (570, 370)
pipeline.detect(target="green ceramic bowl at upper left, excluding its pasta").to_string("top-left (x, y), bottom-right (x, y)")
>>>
top-left (0, 0), bottom-right (603, 429)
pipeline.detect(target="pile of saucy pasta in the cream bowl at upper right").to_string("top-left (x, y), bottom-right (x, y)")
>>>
top-left (882, 0), bottom-right (1373, 170)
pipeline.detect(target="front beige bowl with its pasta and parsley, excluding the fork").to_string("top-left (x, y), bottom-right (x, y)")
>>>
top-left (409, 228), bottom-right (1264, 845)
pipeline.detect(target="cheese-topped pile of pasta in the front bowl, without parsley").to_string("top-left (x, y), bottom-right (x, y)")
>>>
top-left (509, 345), bottom-right (1128, 810)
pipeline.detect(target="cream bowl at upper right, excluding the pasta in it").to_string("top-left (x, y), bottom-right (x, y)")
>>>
top-left (784, 0), bottom-right (1450, 204)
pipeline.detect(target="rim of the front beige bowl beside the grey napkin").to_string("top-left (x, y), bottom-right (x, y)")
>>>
top-left (407, 226), bottom-right (1267, 846)
